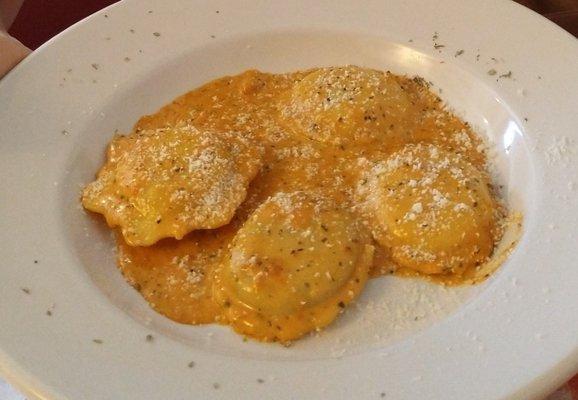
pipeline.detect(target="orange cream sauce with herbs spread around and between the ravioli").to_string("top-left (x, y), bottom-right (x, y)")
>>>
top-left (101, 66), bottom-right (506, 342)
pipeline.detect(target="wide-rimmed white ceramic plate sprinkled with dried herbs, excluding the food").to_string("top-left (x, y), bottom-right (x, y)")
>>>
top-left (0, 0), bottom-right (578, 400)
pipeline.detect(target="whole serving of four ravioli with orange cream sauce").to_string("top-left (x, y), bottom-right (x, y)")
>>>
top-left (82, 66), bottom-right (509, 344)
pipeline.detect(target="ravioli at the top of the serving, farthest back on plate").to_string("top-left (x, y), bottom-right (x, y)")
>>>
top-left (280, 66), bottom-right (415, 147)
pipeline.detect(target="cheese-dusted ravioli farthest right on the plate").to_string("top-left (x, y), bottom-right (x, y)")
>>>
top-left (356, 144), bottom-right (500, 274)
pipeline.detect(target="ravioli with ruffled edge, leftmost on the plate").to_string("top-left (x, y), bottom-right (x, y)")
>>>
top-left (82, 125), bottom-right (262, 246)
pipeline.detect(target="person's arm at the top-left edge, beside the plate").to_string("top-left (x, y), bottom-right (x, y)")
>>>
top-left (0, 0), bottom-right (30, 78)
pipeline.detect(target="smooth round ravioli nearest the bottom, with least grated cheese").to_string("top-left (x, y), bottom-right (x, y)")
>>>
top-left (218, 192), bottom-right (373, 342)
